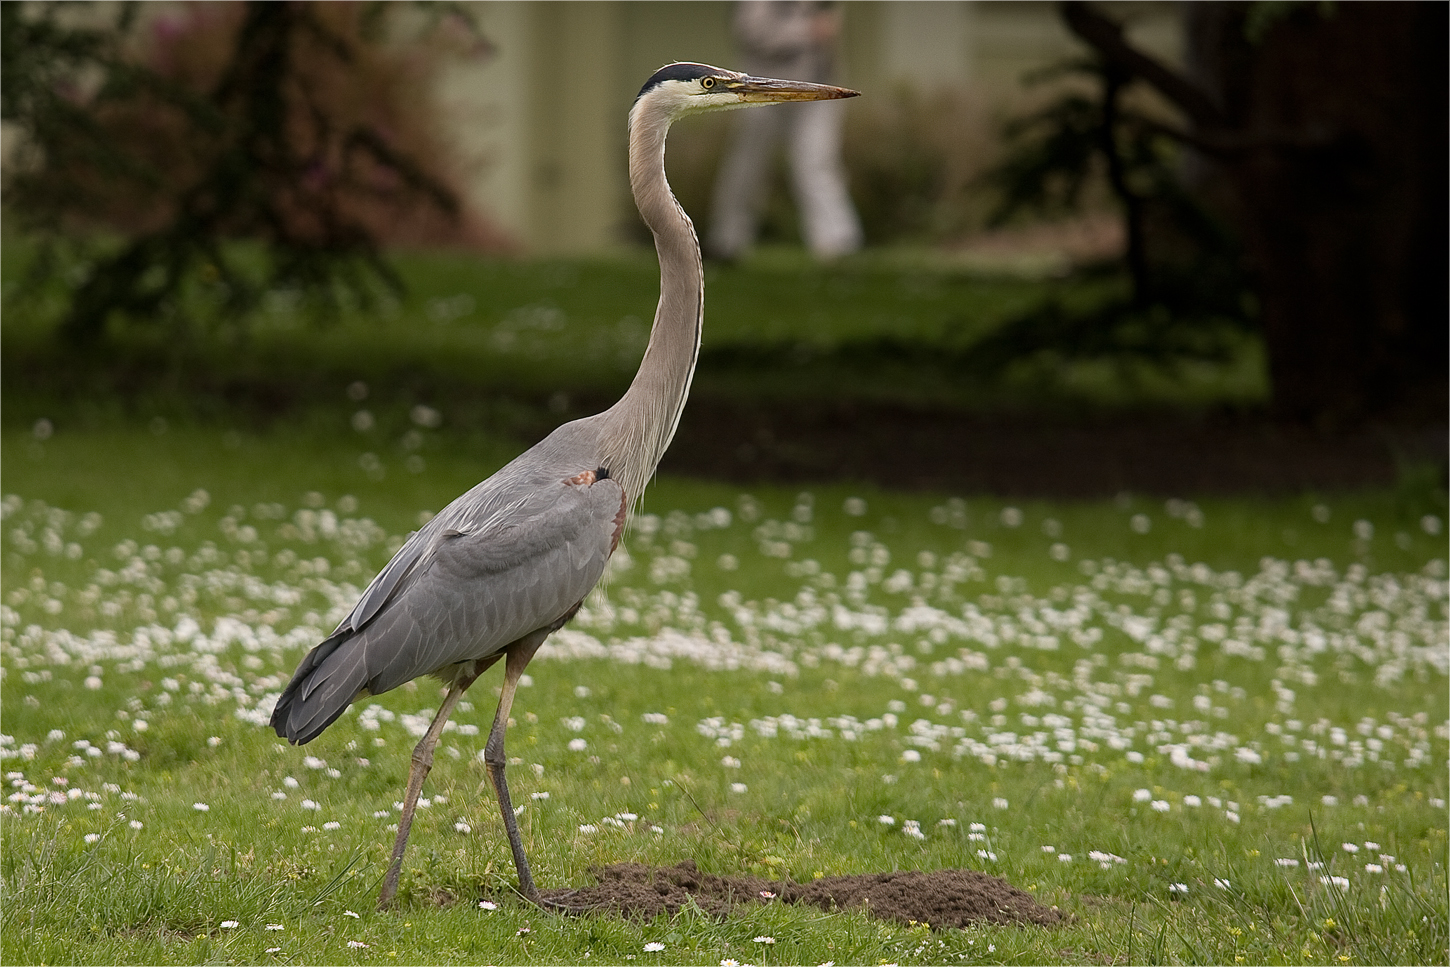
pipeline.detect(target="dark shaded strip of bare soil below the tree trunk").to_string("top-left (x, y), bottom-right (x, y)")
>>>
top-left (660, 396), bottom-right (1447, 499)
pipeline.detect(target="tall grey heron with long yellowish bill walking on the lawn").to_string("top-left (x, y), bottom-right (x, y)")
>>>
top-left (271, 64), bottom-right (856, 908)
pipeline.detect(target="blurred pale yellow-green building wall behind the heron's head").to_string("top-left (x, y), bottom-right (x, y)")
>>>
top-left (439, 0), bottom-right (1182, 254)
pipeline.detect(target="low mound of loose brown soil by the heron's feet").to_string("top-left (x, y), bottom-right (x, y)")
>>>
top-left (542, 860), bottom-right (1063, 929)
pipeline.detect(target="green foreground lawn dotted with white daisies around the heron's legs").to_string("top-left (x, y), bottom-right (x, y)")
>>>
top-left (0, 429), bottom-right (1450, 964)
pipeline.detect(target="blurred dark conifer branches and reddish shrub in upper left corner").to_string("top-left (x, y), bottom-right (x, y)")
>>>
top-left (0, 3), bottom-right (487, 348)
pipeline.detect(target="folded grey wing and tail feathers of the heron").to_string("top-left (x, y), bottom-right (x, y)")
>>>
top-left (271, 478), bottom-right (625, 742)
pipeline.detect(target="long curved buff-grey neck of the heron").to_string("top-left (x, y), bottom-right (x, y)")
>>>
top-left (603, 103), bottom-right (705, 500)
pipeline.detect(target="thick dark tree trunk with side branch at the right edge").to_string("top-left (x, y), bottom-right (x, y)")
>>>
top-left (1066, 3), bottom-right (1450, 422)
